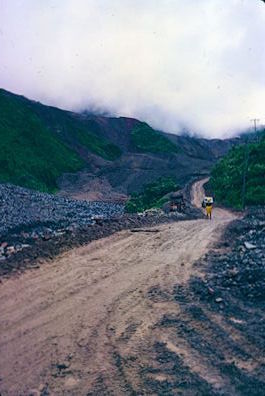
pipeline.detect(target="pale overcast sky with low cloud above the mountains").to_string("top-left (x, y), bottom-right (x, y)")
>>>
top-left (0, 0), bottom-right (265, 137)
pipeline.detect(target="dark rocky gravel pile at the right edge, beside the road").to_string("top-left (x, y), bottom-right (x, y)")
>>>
top-left (191, 207), bottom-right (265, 309)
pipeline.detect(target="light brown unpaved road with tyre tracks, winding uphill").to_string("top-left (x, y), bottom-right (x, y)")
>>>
top-left (0, 181), bottom-right (235, 396)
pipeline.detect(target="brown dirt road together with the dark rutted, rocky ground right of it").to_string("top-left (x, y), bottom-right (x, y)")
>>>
top-left (0, 182), bottom-right (265, 396)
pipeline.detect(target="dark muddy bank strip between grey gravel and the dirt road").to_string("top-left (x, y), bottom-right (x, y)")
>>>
top-left (0, 209), bottom-right (200, 279)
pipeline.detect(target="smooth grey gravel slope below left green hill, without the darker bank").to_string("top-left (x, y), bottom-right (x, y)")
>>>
top-left (0, 184), bottom-right (124, 236)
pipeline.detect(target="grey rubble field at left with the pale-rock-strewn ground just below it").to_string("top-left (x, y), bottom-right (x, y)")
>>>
top-left (0, 184), bottom-right (124, 272)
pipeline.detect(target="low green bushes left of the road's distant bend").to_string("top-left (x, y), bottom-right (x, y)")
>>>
top-left (125, 177), bottom-right (180, 213)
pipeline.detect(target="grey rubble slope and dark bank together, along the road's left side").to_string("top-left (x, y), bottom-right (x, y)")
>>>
top-left (0, 184), bottom-right (201, 276)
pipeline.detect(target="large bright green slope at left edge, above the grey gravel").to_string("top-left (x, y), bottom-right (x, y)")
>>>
top-left (0, 91), bottom-right (83, 192)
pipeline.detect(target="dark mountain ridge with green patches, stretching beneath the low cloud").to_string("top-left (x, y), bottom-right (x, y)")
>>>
top-left (0, 89), bottom-right (237, 200)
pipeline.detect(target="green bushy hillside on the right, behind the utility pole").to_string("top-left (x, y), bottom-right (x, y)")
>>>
top-left (209, 133), bottom-right (265, 208)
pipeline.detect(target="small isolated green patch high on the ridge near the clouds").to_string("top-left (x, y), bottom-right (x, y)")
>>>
top-left (131, 122), bottom-right (179, 154)
